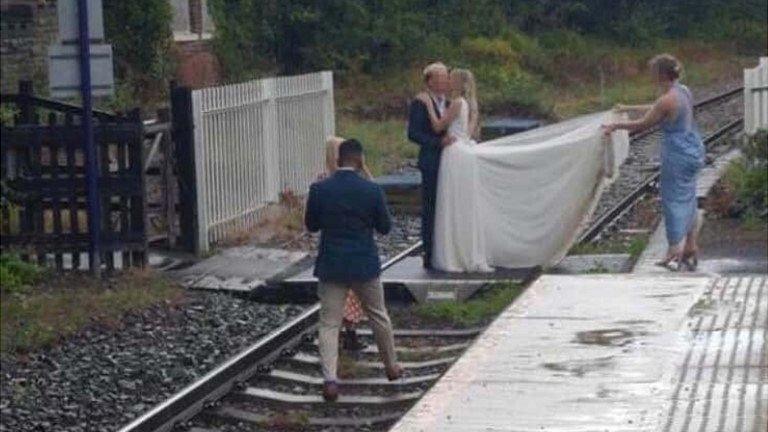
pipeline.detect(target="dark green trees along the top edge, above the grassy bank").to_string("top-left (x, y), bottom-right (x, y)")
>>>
top-left (209, 0), bottom-right (768, 77)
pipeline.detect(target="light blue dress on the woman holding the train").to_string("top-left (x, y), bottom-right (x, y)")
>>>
top-left (661, 83), bottom-right (704, 246)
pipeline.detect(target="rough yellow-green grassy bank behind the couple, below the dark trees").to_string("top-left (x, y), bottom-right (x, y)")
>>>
top-left (337, 39), bottom-right (755, 176)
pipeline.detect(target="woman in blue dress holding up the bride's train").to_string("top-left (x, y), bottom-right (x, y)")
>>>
top-left (604, 54), bottom-right (704, 270)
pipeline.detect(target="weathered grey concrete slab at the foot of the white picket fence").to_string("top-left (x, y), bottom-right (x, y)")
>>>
top-left (172, 246), bottom-right (309, 292)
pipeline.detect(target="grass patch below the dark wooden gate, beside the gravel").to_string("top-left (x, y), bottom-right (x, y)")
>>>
top-left (0, 270), bottom-right (184, 354)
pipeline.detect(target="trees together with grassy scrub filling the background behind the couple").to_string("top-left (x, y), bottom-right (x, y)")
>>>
top-left (210, 0), bottom-right (768, 118)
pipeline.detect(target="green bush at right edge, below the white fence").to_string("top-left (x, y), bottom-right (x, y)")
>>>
top-left (724, 130), bottom-right (768, 225)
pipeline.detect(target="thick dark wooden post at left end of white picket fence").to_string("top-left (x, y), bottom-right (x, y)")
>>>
top-left (171, 82), bottom-right (199, 252)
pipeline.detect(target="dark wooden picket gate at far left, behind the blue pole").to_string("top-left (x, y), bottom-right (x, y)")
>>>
top-left (0, 82), bottom-right (147, 270)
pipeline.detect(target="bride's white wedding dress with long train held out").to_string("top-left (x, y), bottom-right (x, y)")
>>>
top-left (432, 99), bottom-right (629, 272)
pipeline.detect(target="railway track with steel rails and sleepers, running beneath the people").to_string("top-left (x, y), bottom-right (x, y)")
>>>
top-left (119, 88), bottom-right (742, 432)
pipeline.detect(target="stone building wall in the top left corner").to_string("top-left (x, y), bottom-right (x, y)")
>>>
top-left (0, 0), bottom-right (58, 94)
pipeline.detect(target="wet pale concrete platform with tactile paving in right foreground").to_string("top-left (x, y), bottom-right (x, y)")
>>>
top-left (391, 275), bottom-right (768, 432)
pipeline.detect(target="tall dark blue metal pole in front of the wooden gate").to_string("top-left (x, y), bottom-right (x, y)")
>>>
top-left (77, 0), bottom-right (101, 276)
